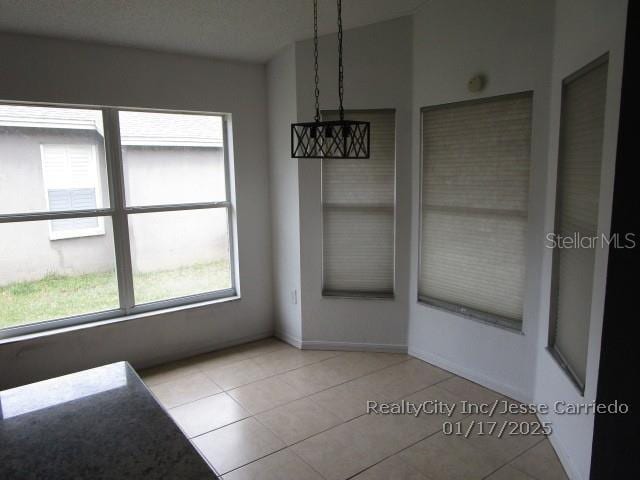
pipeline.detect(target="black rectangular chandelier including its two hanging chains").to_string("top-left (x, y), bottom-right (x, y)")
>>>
top-left (291, 0), bottom-right (370, 158)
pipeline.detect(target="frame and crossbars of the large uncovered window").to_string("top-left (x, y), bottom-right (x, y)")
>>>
top-left (0, 101), bottom-right (240, 341)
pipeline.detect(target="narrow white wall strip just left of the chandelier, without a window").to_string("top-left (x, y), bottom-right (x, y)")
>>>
top-left (267, 45), bottom-right (302, 344)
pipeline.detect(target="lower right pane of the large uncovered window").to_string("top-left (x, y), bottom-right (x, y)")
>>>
top-left (129, 208), bottom-right (231, 304)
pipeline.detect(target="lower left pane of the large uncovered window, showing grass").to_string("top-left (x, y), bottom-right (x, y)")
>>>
top-left (0, 217), bottom-right (119, 328)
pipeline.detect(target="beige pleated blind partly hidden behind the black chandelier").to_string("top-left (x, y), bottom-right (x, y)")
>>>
top-left (322, 110), bottom-right (395, 295)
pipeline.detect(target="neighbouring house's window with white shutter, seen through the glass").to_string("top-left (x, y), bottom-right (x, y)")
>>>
top-left (40, 144), bottom-right (105, 240)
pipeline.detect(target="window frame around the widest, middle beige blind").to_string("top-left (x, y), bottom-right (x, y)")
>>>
top-left (416, 90), bottom-right (535, 335)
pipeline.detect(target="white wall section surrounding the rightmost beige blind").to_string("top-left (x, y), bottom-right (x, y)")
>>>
top-left (535, 0), bottom-right (627, 480)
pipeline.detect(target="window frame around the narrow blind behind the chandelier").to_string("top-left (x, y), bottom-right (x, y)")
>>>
top-left (320, 108), bottom-right (398, 300)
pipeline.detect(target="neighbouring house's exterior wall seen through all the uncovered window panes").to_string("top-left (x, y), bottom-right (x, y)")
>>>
top-left (0, 127), bottom-right (228, 286)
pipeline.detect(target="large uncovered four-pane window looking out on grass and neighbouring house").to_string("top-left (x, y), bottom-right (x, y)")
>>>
top-left (0, 105), bottom-right (236, 337)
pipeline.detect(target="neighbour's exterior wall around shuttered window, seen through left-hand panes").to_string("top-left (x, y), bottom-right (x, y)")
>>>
top-left (0, 127), bottom-right (115, 286)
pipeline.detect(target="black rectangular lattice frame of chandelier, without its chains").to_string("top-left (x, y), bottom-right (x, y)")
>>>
top-left (291, 120), bottom-right (371, 159)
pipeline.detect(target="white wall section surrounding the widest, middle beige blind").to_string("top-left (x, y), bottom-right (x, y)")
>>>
top-left (409, 0), bottom-right (553, 400)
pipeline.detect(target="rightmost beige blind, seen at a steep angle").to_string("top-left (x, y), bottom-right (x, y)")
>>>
top-left (551, 59), bottom-right (607, 386)
